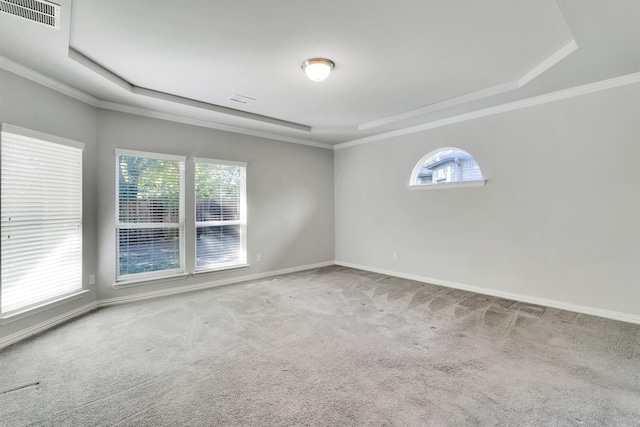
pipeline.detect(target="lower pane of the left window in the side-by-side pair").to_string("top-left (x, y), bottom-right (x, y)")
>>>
top-left (118, 227), bottom-right (181, 276)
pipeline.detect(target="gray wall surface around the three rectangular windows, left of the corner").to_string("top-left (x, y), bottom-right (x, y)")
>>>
top-left (0, 70), bottom-right (335, 339)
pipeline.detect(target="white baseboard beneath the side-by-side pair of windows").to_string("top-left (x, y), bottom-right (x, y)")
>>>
top-left (98, 261), bottom-right (335, 307)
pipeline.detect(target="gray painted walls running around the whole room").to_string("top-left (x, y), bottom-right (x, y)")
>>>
top-left (0, 66), bottom-right (640, 339)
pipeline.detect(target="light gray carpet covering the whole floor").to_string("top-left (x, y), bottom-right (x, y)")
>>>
top-left (0, 267), bottom-right (640, 426)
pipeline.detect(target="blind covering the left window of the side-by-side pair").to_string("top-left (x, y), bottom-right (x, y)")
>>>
top-left (116, 150), bottom-right (185, 281)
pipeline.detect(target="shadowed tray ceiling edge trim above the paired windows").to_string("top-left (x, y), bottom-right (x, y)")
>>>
top-left (69, 46), bottom-right (311, 132)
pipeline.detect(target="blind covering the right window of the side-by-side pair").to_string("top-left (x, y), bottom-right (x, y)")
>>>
top-left (195, 158), bottom-right (247, 271)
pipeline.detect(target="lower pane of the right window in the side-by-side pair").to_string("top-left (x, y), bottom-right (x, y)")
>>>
top-left (196, 225), bottom-right (240, 270)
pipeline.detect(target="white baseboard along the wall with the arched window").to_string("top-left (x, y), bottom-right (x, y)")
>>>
top-left (335, 261), bottom-right (640, 325)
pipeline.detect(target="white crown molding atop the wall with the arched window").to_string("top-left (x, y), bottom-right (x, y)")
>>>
top-left (333, 72), bottom-right (640, 150)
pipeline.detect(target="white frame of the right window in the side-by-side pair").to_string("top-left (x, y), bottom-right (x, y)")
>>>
top-left (192, 157), bottom-right (248, 274)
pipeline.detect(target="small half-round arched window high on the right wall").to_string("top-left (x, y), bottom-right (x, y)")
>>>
top-left (409, 147), bottom-right (486, 188)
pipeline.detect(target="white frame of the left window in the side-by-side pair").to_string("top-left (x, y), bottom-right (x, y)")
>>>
top-left (114, 148), bottom-right (187, 286)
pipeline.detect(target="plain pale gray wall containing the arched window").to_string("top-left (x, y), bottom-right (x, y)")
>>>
top-left (335, 84), bottom-right (640, 320)
